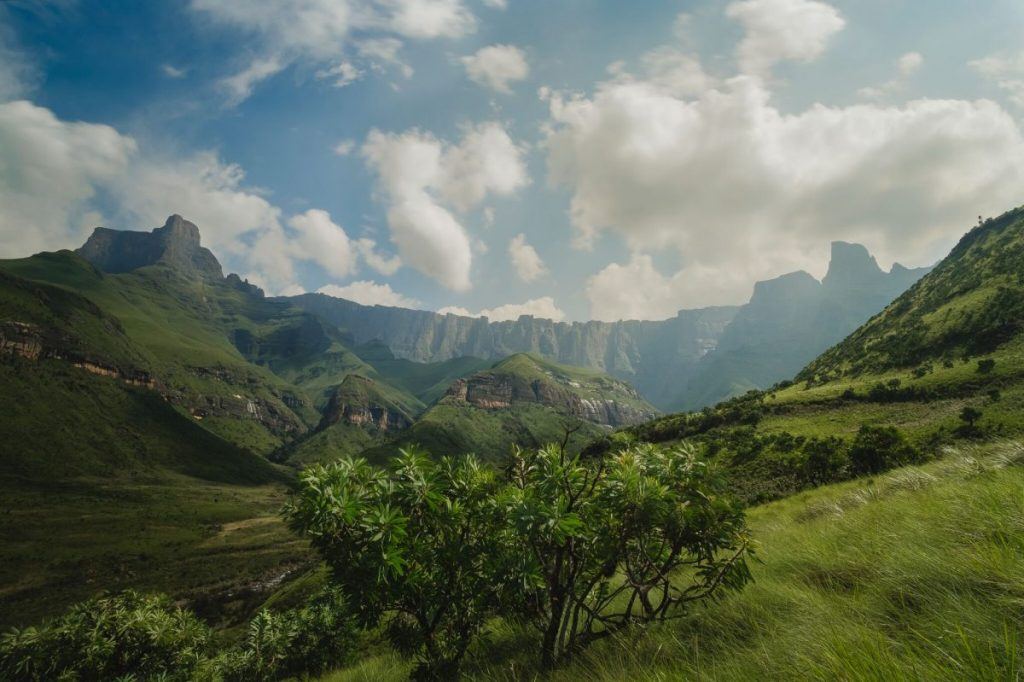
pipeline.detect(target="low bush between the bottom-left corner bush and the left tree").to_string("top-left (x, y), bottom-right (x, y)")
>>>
top-left (213, 588), bottom-right (358, 682)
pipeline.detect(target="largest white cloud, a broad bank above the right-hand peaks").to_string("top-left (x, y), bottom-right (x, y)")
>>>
top-left (545, 67), bottom-right (1024, 307)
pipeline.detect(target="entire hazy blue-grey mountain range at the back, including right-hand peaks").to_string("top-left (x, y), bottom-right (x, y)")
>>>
top-left (281, 242), bottom-right (928, 410)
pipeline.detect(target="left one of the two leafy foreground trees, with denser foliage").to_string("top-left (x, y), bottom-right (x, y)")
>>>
top-left (285, 450), bottom-right (511, 679)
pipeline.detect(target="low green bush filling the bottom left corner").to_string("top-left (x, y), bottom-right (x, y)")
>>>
top-left (0, 591), bottom-right (211, 682)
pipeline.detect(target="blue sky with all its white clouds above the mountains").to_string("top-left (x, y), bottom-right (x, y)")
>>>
top-left (0, 0), bottom-right (1024, 321)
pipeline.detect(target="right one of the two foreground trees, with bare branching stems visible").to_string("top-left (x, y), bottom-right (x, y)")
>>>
top-left (501, 438), bottom-right (750, 669)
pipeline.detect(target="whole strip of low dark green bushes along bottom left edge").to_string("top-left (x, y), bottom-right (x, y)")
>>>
top-left (0, 589), bottom-right (358, 682)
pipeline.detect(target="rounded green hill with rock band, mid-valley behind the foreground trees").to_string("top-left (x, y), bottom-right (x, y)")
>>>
top-left (368, 353), bottom-right (657, 462)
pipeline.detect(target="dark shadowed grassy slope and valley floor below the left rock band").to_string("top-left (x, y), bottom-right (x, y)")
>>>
top-left (0, 360), bottom-right (308, 627)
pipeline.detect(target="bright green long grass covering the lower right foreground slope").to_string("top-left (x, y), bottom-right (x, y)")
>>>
top-left (325, 441), bottom-right (1024, 682)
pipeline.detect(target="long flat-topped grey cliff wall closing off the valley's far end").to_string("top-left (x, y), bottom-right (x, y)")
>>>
top-left (283, 294), bottom-right (736, 404)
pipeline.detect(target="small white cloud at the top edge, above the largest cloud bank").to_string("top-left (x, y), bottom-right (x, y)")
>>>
top-left (726, 0), bottom-right (846, 75)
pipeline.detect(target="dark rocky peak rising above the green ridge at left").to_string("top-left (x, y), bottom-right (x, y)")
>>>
top-left (76, 214), bottom-right (223, 280)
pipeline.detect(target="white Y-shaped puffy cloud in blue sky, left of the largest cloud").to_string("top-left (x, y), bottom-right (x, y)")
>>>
top-left (361, 123), bottom-right (527, 291)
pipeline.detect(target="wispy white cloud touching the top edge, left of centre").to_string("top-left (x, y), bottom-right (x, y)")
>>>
top-left (190, 0), bottom-right (476, 104)
